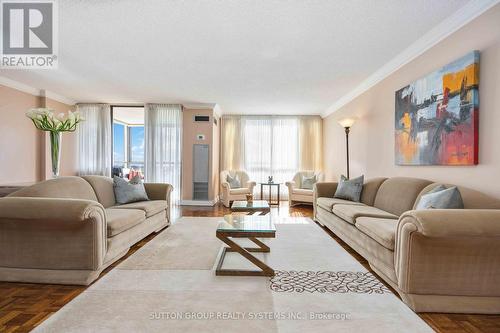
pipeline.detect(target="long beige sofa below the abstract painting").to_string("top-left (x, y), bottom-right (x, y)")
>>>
top-left (314, 177), bottom-right (500, 314)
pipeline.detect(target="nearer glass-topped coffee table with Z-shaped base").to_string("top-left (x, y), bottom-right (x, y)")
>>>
top-left (215, 215), bottom-right (276, 276)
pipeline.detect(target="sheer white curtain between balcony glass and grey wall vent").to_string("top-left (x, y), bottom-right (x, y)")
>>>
top-left (144, 104), bottom-right (182, 204)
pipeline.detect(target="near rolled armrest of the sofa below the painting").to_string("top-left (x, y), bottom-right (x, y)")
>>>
top-left (395, 209), bottom-right (500, 296)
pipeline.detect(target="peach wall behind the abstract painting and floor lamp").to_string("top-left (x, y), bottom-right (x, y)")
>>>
top-left (323, 5), bottom-right (500, 197)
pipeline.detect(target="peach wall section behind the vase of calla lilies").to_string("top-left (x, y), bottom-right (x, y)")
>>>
top-left (0, 85), bottom-right (77, 185)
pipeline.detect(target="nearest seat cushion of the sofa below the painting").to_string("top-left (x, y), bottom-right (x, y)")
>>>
top-left (356, 216), bottom-right (399, 251)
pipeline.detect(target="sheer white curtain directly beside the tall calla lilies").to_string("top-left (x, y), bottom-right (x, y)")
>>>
top-left (76, 104), bottom-right (111, 177)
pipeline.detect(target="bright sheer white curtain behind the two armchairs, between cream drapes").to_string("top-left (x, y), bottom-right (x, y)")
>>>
top-left (241, 116), bottom-right (299, 199)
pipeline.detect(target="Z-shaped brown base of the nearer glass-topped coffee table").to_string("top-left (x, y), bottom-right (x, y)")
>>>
top-left (215, 232), bottom-right (274, 276)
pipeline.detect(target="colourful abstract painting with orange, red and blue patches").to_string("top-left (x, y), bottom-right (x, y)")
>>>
top-left (395, 51), bottom-right (479, 165)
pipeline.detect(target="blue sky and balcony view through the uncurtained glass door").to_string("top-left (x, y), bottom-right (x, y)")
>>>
top-left (113, 106), bottom-right (144, 179)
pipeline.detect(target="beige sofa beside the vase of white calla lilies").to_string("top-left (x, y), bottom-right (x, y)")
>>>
top-left (0, 176), bottom-right (172, 285)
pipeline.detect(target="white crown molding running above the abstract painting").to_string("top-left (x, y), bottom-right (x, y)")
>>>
top-left (321, 0), bottom-right (500, 118)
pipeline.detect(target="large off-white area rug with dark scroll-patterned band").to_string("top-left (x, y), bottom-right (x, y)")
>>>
top-left (35, 217), bottom-right (432, 333)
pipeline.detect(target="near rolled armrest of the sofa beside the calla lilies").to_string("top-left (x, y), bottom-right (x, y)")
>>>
top-left (0, 197), bottom-right (107, 270)
